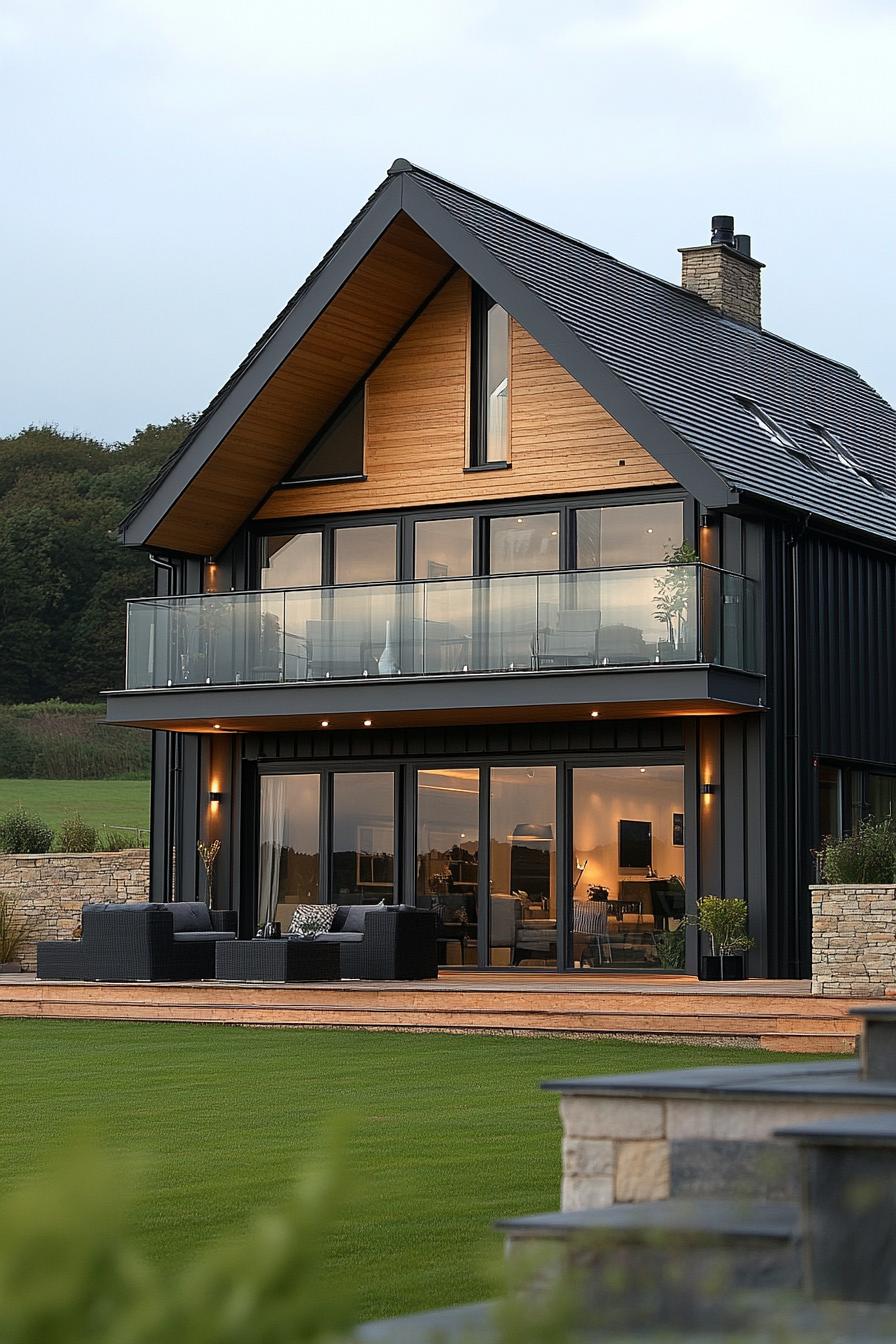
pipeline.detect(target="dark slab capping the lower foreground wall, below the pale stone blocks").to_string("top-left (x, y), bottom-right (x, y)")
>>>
top-left (494, 1199), bottom-right (799, 1243)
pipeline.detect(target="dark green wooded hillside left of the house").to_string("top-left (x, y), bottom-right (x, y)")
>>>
top-left (0, 415), bottom-right (193, 704)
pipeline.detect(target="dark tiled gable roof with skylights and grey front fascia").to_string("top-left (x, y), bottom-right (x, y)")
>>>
top-left (122, 160), bottom-right (896, 554)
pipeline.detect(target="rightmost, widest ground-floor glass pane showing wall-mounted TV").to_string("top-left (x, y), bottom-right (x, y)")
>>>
top-left (567, 765), bottom-right (685, 969)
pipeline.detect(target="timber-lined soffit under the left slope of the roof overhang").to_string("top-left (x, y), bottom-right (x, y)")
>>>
top-left (149, 215), bottom-right (453, 555)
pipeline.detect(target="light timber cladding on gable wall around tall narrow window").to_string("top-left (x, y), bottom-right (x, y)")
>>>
top-left (255, 273), bottom-right (672, 520)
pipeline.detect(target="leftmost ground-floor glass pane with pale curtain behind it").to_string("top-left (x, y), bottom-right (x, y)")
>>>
top-left (258, 774), bottom-right (321, 931)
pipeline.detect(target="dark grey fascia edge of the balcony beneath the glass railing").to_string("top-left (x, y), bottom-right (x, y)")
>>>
top-left (105, 664), bottom-right (764, 731)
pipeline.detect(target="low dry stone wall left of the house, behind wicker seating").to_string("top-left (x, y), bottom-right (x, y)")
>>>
top-left (0, 849), bottom-right (149, 970)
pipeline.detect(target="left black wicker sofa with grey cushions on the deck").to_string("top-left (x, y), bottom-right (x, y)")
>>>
top-left (38, 900), bottom-right (236, 981)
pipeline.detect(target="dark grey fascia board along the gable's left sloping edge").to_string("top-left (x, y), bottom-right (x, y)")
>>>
top-left (121, 177), bottom-right (402, 546)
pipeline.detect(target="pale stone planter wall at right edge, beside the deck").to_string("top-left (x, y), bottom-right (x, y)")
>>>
top-left (811, 884), bottom-right (896, 999)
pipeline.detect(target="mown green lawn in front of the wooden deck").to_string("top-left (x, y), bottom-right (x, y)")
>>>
top-left (0, 1020), bottom-right (827, 1317)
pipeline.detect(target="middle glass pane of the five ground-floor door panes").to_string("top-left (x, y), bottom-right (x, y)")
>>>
top-left (416, 769), bottom-right (480, 965)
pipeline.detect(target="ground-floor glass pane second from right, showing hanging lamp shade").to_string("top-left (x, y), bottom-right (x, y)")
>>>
top-left (489, 766), bottom-right (557, 966)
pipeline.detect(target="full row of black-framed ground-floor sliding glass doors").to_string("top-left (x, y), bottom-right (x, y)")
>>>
top-left (257, 758), bottom-right (686, 970)
